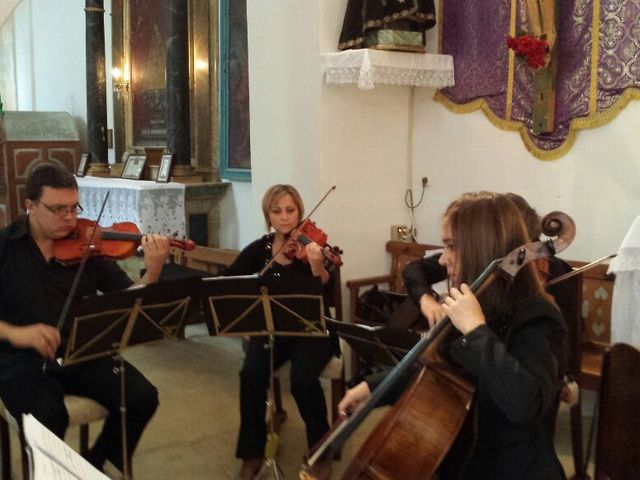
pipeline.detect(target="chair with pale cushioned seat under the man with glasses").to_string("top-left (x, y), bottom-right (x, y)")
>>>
top-left (0, 395), bottom-right (108, 480)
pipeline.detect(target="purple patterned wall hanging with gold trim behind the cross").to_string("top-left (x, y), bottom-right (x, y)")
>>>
top-left (436, 0), bottom-right (640, 158)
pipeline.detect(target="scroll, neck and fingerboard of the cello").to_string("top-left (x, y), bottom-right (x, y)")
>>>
top-left (305, 211), bottom-right (575, 468)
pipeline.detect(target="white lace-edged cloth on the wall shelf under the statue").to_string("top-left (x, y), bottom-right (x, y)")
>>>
top-left (322, 48), bottom-right (455, 90)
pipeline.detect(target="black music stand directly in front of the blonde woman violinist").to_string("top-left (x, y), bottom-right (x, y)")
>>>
top-left (202, 275), bottom-right (327, 479)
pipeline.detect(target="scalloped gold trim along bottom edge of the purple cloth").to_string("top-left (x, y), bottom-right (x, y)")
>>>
top-left (433, 87), bottom-right (640, 160)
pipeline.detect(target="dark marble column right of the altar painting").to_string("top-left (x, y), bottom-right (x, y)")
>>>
top-left (165, 0), bottom-right (191, 167)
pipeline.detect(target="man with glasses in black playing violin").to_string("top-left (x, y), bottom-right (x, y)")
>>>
top-left (0, 164), bottom-right (169, 470)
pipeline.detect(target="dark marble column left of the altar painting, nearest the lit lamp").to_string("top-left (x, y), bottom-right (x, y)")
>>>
top-left (84, 0), bottom-right (109, 175)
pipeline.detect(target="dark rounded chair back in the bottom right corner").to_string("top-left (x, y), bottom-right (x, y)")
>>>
top-left (595, 343), bottom-right (640, 480)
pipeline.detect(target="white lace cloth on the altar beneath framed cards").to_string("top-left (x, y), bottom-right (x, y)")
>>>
top-left (77, 177), bottom-right (186, 239)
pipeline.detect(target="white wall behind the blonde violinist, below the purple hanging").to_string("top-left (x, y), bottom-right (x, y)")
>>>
top-left (237, 0), bottom-right (640, 312)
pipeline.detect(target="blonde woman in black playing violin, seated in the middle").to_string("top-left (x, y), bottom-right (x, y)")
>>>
top-left (225, 185), bottom-right (337, 479)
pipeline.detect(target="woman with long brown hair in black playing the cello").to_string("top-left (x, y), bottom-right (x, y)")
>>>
top-left (338, 192), bottom-right (567, 480)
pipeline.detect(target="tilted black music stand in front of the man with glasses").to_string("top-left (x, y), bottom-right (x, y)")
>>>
top-left (60, 278), bottom-right (200, 479)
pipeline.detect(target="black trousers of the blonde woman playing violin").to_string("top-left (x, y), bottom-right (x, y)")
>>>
top-left (236, 337), bottom-right (334, 458)
